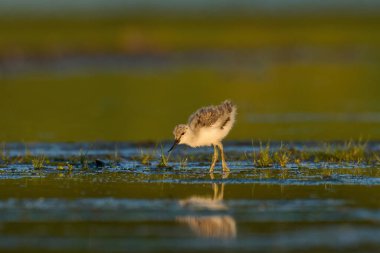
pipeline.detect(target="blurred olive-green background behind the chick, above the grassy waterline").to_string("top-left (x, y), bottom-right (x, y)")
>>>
top-left (0, 0), bottom-right (380, 141)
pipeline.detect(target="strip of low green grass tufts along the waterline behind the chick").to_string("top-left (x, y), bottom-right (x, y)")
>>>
top-left (0, 141), bottom-right (380, 170)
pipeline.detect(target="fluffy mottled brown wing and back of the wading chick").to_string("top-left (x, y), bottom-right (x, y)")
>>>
top-left (188, 101), bottom-right (233, 131)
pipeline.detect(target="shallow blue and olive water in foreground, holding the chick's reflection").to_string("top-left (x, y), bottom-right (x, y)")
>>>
top-left (0, 143), bottom-right (380, 252)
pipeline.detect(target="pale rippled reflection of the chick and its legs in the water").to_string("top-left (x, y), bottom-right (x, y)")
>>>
top-left (177, 174), bottom-right (237, 239)
